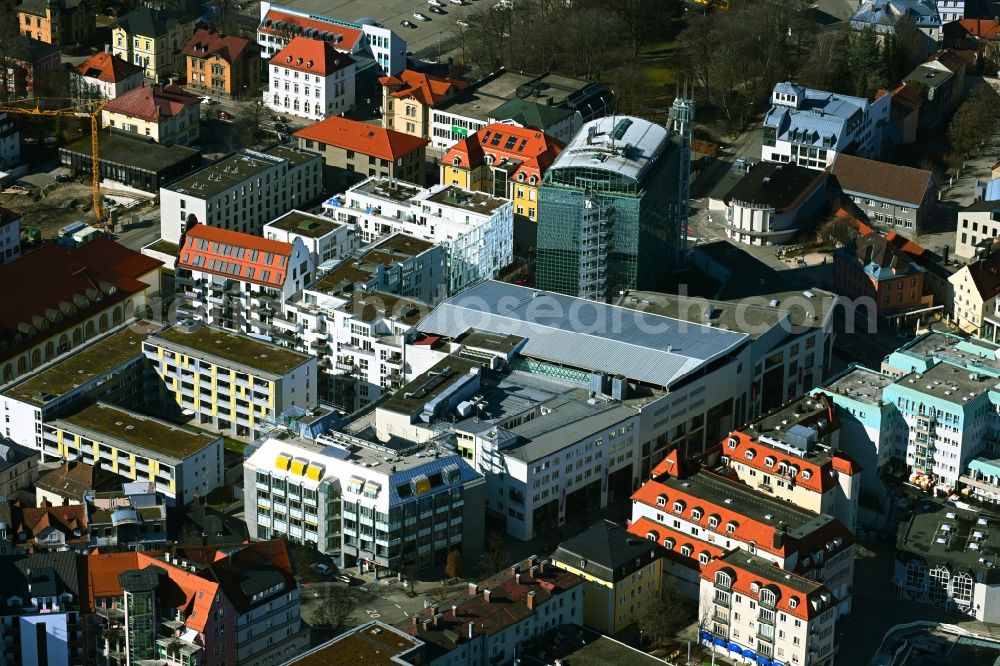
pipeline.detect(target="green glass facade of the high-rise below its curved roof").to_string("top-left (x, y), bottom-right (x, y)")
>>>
top-left (536, 139), bottom-right (680, 299)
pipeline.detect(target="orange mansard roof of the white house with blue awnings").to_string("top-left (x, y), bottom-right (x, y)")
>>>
top-left (701, 552), bottom-right (833, 620)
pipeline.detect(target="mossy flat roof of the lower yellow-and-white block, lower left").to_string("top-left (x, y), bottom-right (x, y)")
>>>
top-left (56, 403), bottom-right (221, 458)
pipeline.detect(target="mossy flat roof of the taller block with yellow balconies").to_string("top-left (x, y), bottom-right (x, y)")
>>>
top-left (149, 326), bottom-right (313, 376)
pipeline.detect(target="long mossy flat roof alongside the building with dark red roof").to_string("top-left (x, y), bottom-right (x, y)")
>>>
top-left (6, 322), bottom-right (154, 407)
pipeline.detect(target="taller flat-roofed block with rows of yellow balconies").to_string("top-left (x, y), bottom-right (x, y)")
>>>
top-left (142, 324), bottom-right (318, 440)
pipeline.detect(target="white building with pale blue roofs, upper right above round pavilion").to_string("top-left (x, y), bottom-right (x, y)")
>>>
top-left (762, 81), bottom-right (892, 170)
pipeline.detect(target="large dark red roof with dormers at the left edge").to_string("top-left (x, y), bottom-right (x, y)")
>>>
top-left (0, 238), bottom-right (163, 361)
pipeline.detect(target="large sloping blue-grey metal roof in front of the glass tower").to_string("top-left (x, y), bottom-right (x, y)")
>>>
top-left (417, 281), bottom-right (750, 386)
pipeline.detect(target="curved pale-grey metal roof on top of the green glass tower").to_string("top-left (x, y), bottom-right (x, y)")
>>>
top-left (549, 116), bottom-right (667, 181)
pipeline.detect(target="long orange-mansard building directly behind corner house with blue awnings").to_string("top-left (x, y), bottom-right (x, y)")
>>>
top-left (630, 449), bottom-right (854, 614)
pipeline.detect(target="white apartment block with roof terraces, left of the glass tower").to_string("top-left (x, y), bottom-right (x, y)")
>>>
top-left (324, 178), bottom-right (514, 294)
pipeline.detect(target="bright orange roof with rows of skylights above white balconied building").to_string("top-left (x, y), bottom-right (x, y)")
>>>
top-left (177, 224), bottom-right (292, 288)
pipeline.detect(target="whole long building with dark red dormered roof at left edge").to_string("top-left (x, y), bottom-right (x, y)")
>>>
top-left (0, 238), bottom-right (163, 384)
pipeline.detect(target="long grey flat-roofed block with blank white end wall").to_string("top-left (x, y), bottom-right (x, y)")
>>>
top-left (160, 146), bottom-right (323, 243)
